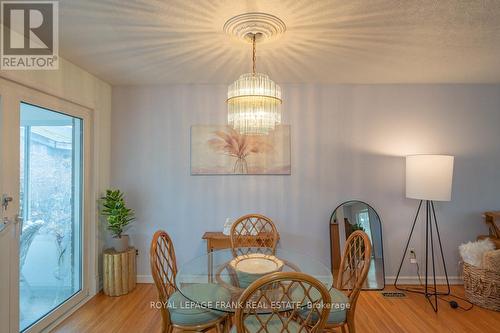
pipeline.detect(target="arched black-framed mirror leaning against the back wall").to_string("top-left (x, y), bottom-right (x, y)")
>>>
top-left (330, 200), bottom-right (385, 290)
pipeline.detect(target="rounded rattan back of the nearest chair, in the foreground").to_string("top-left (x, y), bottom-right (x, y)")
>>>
top-left (231, 272), bottom-right (330, 333)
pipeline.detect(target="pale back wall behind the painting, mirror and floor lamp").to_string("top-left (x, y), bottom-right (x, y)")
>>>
top-left (112, 84), bottom-right (500, 282)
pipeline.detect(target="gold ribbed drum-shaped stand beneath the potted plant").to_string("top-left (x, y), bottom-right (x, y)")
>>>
top-left (103, 247), bottom-right (137, 296)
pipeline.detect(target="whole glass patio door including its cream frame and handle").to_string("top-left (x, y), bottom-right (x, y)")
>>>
top-left (0, 78), bottom-right (91, 333)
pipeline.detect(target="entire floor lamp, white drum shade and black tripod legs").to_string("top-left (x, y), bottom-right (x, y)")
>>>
top-left (394, 155), bottom-right (454, 312)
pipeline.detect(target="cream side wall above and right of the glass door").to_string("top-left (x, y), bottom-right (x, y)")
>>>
top-left (0, 59), bottom-right (111, 294)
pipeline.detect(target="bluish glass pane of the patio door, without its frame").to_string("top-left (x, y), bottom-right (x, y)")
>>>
top-left (19, 103), bottom-right (82, 331)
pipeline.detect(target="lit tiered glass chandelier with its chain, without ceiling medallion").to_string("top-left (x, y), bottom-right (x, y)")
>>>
top-left (227, 33), bottom-right (282, 135)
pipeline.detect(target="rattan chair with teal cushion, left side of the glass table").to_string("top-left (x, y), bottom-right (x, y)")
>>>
top-left (150, 230), bottom-right (229, 333)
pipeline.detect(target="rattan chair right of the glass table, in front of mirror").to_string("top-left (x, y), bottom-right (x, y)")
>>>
top-left (325, 230), bottom-right (371, 333)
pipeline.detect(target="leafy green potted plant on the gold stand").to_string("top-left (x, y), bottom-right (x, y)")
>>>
top-left (101, 190), bottom-right (135, 252)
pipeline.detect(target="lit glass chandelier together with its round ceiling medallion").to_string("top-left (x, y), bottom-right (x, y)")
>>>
top-left (224, 13), bottom-right (285, 135)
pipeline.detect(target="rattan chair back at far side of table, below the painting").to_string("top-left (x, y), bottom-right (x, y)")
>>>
top-left (230, 214), bottom-right (279, 257)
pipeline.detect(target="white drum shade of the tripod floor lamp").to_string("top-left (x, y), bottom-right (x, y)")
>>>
top-left (406, 155), bottom-right (454, 201)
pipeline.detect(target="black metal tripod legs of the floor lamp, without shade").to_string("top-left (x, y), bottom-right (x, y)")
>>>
top-left (394, 200), bottom-right (450, 312)
